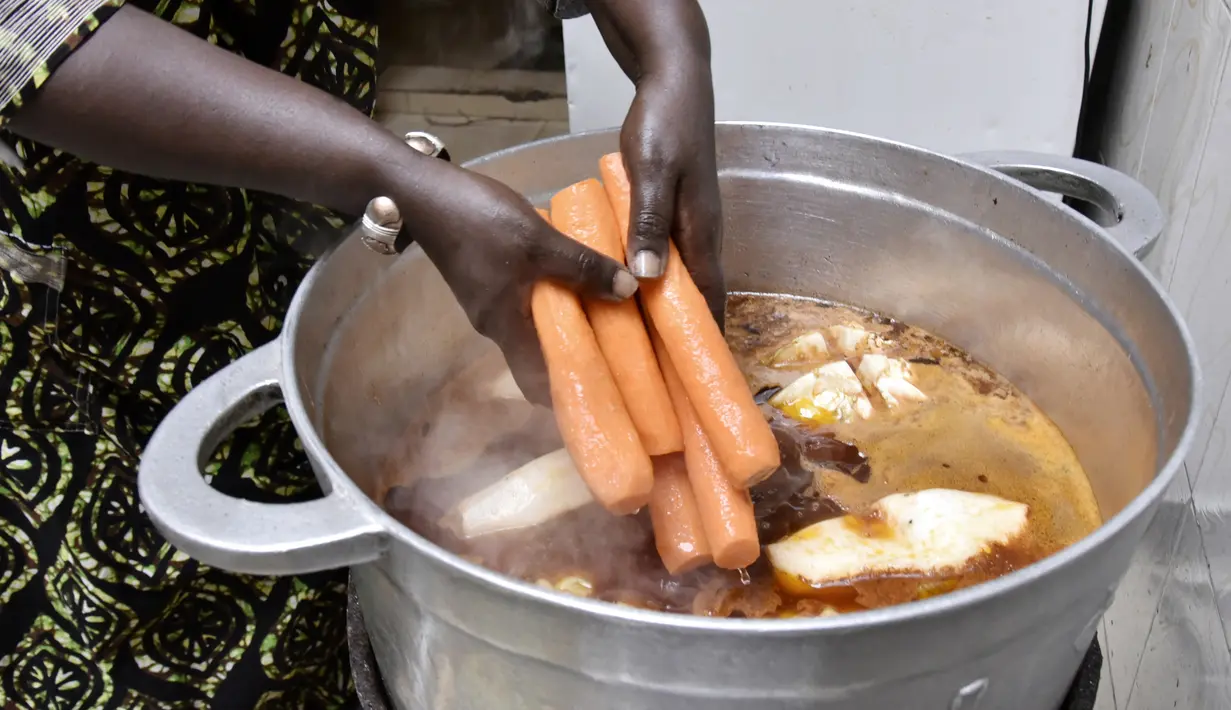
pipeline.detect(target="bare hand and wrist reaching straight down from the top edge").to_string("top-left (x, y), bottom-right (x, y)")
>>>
top-left (588, 0), bottom-right (726, 325)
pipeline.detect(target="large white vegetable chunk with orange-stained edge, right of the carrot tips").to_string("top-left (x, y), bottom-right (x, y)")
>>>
top-left (766, 489), bottom-right (1029, 587)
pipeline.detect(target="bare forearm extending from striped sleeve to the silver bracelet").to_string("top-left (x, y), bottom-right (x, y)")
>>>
top-left (7, 6), bottom-right (416, 214)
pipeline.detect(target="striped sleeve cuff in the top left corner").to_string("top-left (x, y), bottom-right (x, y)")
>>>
top-left (0, 0), bottom-right (124, 127)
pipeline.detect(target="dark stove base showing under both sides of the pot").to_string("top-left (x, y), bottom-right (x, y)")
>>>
top-left (346, 575), bottom-right (1103, 710)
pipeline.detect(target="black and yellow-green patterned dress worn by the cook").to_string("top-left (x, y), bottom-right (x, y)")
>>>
top-left (0, 0), bottom-right (576, 710)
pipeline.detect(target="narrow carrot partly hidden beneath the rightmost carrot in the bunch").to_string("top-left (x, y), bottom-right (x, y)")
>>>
top-left (651, 332), bottom-right (761, 570)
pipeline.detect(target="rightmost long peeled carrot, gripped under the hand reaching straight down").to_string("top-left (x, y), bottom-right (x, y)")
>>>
top-left (599, 154), bottom-right (780, 487)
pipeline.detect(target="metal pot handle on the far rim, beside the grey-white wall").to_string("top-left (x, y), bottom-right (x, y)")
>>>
top-left (958, 150), bottom-right (1167, 258)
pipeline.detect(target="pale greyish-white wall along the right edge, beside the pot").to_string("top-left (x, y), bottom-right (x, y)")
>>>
top-left (1099, 0), bottom-right (1231, 710)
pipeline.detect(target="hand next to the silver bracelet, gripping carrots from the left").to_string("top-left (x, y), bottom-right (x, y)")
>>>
top-left (391, 155), bottom-right (636, 405)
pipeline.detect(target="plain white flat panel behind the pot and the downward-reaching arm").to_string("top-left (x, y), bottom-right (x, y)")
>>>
top-left (564, 0), bottom-right (1107, 154)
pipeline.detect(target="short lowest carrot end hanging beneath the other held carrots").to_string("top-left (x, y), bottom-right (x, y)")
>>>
top-left (650, 454), bottom-right (713, 575)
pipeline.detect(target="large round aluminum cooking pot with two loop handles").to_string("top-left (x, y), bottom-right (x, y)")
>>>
top-left (139, 124), bottom-right (1199, 710)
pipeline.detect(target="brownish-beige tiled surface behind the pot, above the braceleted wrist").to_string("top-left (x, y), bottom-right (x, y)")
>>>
top-left (377, 66), bottom-right (569, 162)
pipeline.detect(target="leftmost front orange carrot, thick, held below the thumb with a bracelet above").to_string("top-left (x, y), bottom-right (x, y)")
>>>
top-left (531, 204), bottom-right (654, 514)
